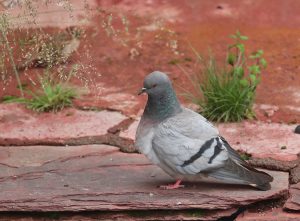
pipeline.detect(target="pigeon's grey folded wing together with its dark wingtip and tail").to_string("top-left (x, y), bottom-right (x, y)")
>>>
top-left (152, 109), bottom-right (272, 190)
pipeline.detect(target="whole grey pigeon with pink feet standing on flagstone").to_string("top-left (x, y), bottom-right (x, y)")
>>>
top-left (135, 71), bottom-right (273, 190)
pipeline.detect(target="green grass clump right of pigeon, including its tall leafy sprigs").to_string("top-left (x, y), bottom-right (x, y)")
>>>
top-left (188, 31), bottom-right (267, 122)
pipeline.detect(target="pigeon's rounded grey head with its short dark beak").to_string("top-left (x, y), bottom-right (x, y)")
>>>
top-left (139, 71), bottom-right (172, 96)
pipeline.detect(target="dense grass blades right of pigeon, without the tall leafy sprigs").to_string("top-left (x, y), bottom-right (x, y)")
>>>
top-left (196, 58), bottom-right (255, 122)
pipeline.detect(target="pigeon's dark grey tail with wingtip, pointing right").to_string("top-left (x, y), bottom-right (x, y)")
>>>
top-left (208, 159), bottom-right (273, 190)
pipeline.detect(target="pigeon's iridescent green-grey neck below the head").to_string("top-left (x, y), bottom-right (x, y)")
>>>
top-left (144, 90), bottom-right (182, 120)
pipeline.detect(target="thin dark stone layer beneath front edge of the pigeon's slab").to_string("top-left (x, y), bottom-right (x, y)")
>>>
top-left (0, 209), bottom-right (236, 221)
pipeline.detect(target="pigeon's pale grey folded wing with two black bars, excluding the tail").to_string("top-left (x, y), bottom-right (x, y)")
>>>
top-left (152, 110), bottom-right (228, 175)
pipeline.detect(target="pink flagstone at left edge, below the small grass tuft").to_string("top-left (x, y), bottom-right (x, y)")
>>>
top-left (0, 104), bottom-right (127, 145)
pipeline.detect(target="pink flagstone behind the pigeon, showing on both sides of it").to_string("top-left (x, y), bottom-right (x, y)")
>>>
top-left (120, 119), bottom-right (300, 162)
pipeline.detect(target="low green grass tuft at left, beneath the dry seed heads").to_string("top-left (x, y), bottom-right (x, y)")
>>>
top-left (3, 65), bottom-right (80, 112)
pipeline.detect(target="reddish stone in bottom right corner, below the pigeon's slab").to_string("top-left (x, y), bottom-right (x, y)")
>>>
top-left (236, 208), bottom-right (300, 221)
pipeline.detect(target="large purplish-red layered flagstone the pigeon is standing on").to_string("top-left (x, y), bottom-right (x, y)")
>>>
top-left (0, 145), bottom-right (288, 211)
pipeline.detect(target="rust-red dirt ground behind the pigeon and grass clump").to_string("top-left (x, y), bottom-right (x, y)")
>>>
top-left (0, 0), bottom-right (300, 123)
